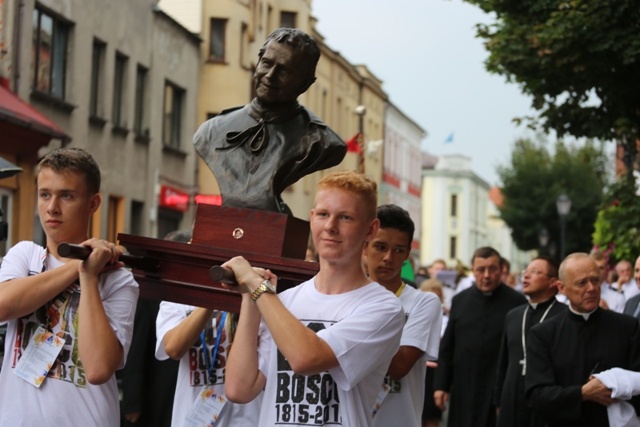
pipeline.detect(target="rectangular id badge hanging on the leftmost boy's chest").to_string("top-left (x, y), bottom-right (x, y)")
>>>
top-left (13, 325), bottom-right (64, 388)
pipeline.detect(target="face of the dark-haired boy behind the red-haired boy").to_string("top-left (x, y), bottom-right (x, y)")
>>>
top-left (364, 227), bottom-right (409, 292)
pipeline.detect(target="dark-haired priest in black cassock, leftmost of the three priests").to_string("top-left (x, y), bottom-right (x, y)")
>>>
top-left (433, 247), bottom-right (526, 427)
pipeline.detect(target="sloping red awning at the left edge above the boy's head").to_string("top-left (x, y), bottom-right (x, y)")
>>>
top-left (0, 84), bottom-right (71, 141)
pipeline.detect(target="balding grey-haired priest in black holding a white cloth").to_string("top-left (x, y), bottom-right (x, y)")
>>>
top-left (525, 253), bottom-right (640, 427)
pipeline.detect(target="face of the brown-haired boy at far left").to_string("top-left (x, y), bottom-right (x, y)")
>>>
top-left (37, 167), bottom-right (100, 246)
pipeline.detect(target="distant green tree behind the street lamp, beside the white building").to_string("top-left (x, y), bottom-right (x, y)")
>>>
top-left (498, 139), bottom-right (609, 260)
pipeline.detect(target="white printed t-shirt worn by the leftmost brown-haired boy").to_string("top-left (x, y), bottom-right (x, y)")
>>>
top-left (0, 241), bottom-right (138, 427)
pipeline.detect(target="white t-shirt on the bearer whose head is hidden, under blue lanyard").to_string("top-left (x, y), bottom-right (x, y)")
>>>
top-left (156, 301), bottom-right (262, 427)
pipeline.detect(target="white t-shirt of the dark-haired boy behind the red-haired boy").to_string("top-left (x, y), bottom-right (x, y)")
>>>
top-left (373, 286), bottom-right (442, 427)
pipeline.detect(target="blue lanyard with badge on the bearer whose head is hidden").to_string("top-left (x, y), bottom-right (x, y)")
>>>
top-left (184, 311), bottom-right (228, 427)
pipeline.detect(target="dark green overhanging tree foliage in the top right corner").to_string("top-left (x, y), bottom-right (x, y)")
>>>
top-left (465, 0), bottom-right (640, 148)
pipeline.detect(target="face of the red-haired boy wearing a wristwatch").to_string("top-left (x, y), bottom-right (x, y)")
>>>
top-left (310, 188), bottom-right (378, 264)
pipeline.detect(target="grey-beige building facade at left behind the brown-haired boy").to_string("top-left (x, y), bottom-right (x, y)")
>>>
top-left (0, 0), bottom-right (201, 258)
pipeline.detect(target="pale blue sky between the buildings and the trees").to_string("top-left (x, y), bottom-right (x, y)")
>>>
top-left (312, 0), bottom-right (535, 185)
